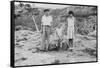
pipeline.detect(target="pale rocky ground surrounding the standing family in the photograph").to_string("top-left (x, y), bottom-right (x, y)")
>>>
top-left (15, 30), bottom-right (96, 66)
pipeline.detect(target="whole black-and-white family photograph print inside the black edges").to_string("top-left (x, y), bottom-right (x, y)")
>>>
top-left (12, 1), bottom-right (98, 66)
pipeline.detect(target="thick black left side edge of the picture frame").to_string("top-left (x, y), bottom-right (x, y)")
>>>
top-left (10, 1), bottom-right (14, 67)
